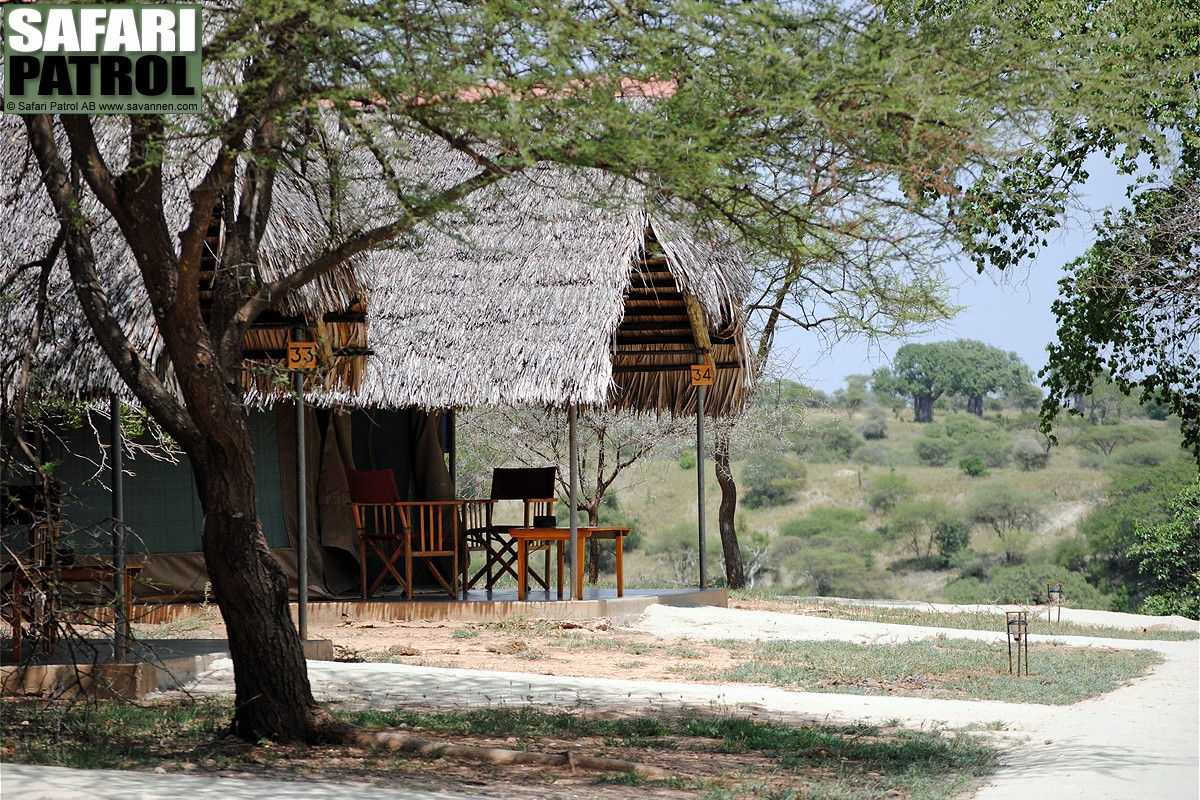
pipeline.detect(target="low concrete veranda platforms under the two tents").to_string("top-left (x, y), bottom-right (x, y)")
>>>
top-left (0, 589), bottom-right (728, 699)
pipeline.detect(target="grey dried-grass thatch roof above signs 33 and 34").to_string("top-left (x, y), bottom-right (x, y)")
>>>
top-left (0, 118), bottom-right (750, 422)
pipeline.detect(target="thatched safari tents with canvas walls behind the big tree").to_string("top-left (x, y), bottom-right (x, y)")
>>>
top-left (0, 112), bottom-right (751, 600)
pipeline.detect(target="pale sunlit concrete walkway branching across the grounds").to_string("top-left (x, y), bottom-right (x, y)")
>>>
top-left (0, 606), bottom-right (1200, 800)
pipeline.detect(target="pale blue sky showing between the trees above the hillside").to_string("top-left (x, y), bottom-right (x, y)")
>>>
top-left (776, 160), bottom-right (1128, 392)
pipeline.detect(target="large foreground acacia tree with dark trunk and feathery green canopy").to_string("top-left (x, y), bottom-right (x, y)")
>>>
top-left (0, 0), bottom-right (1190, 741)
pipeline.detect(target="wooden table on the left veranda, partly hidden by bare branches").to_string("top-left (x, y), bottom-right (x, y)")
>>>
top-left (5, 564), bottom-right (145, 663)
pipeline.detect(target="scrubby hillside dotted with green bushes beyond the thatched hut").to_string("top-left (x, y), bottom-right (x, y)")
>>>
top-left (601, 404), bottom-right (1195, 609)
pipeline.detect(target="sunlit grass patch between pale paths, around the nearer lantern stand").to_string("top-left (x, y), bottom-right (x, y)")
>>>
top-left (718, 637), bottom-right (1162, 705)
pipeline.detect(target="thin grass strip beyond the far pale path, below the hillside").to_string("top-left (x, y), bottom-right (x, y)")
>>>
top-left (756, 595), bottom-right (1200, 642)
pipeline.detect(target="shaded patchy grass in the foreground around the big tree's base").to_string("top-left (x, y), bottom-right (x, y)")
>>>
top-left (0, 699), bottom-right (996, 800)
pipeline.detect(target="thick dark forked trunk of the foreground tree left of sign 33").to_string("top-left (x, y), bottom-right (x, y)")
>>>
top-left (25, 116), bottom-right (349, 742)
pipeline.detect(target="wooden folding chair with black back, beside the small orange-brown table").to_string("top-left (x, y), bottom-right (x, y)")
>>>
top-left (462, 467), bottom-right (558, 590)
